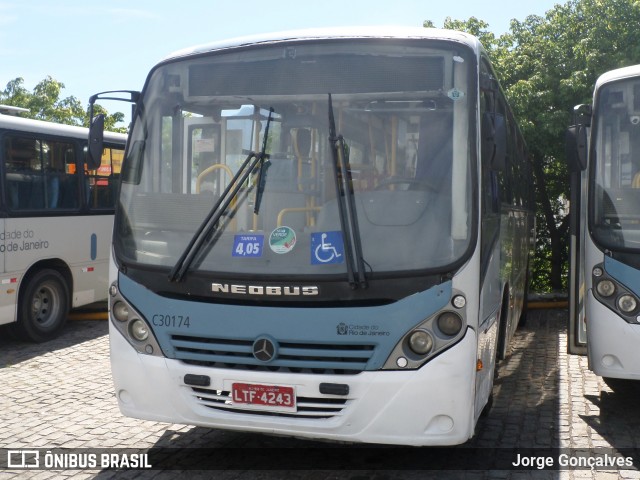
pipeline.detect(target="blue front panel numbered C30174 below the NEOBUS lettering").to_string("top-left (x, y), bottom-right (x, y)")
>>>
top-left (119, 275), bottom-right (452, 370)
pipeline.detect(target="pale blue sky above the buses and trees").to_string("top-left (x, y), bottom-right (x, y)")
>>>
top-left (0, 0), bottom-right (565, 124)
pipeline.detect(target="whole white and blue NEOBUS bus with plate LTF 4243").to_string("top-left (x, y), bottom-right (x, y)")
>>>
top-left (87, 28), bottom-right (534, 445)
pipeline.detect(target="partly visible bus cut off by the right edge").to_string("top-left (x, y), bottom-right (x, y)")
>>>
top-left (568, 65), bottom-right (640, 380)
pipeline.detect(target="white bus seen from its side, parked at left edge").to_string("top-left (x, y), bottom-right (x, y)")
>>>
top-left (0, 106), bottom-right (126, 342)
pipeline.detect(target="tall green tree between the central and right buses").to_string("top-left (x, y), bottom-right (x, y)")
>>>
top-left (424, 0), bottom-right (640, 291)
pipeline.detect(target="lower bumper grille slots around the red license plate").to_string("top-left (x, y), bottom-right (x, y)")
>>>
top-left (191, 387), bottom-right (348, 420)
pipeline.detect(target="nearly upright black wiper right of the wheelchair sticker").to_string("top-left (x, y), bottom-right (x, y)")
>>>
top-left (329, 94), bottom-right (367, 289)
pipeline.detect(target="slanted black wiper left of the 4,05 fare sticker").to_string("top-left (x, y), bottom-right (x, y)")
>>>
top-left (169, 108), bottom-right (273, 282)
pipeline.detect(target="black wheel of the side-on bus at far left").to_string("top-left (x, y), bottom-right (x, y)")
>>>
top-left (14, 269), bottom-right (69, 343)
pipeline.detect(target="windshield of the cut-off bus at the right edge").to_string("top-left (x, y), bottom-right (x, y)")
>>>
top-left (591, 78), bottom-right (640, 251)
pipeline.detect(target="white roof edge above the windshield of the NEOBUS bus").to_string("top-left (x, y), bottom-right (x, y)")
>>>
top-left (162, 25), bottom-right (480, 62)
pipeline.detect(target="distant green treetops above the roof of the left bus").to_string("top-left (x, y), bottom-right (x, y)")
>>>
top-left (0, 76), bottom-right (126, 132)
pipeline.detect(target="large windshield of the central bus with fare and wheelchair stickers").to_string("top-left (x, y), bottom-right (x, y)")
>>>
top-left (115, 39), bottom-right (477, 277)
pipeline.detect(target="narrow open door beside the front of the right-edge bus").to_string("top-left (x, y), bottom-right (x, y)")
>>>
top-left (566, 110), bottom-right (591, 355)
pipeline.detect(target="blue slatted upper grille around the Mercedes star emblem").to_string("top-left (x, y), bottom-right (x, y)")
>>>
top-left (171, 335), bottom-right (375, 375)
